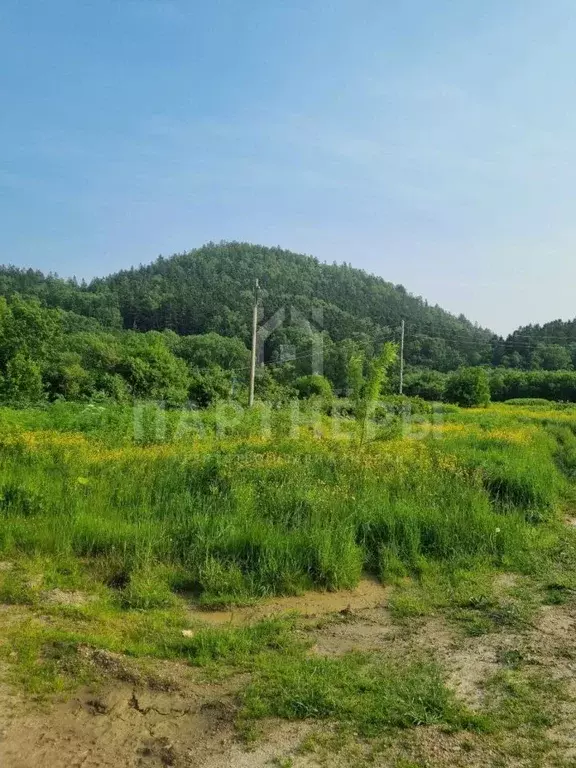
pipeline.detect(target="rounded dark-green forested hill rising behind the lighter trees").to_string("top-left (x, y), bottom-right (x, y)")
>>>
top-left (0, 243), bottom-right (494, 371)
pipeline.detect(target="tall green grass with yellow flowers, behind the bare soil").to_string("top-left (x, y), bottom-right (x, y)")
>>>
top-left (0, 404), bottom-right (576, 608)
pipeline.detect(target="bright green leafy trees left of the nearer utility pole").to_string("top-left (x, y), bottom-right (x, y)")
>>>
top-left (0, 295), bottom-right (249, 405)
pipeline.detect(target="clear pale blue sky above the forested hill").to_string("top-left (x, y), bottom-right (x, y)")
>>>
top-left (0, 0), bottom-right (576, 332)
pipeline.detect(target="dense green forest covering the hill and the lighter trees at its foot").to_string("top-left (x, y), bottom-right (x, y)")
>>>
top-left (0, 243), bottom-right (576, 405)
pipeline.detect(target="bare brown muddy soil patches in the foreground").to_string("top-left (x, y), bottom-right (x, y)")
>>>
top-left (0, 581), bottom-right (576, 768)
